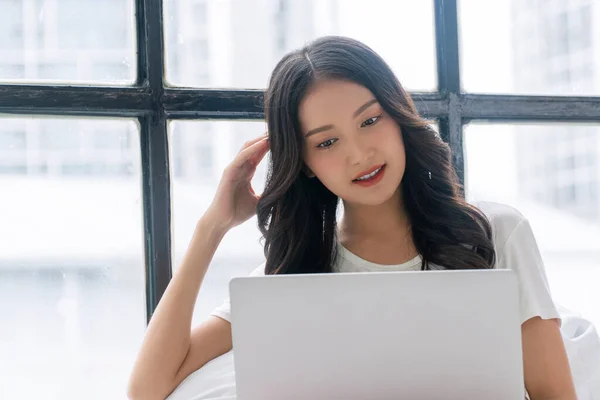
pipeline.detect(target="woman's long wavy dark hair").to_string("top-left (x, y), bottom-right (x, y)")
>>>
top-left (257, 36), bottom-right (495, 274)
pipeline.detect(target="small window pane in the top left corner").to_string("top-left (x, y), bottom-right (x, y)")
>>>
top-left (0, 0), bottom-right (136, 84)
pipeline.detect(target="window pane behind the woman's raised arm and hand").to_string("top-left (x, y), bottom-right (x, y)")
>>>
top-left (169, 121), bottom-right (268, 323)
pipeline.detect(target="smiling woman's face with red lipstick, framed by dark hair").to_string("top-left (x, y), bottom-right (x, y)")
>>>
top-left (299, 80), bottom-right (406, 205)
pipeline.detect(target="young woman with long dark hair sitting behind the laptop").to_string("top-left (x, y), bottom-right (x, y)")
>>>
top-left (129, 37), bottom-right (576, 400)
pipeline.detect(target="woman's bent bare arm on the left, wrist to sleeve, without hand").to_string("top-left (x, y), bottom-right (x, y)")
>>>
top-left (128, 216), bottom-right (231, 400)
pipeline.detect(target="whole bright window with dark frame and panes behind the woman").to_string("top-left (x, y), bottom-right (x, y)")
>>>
top-left (0, 0), bottom-right (600, 400)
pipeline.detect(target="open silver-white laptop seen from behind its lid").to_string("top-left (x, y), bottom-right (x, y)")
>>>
top-left (230, 270), bottom-right (525, 400)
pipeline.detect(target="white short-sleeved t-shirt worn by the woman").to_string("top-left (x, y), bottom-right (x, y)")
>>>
top-left (212, 202), bottom-right (560, 323)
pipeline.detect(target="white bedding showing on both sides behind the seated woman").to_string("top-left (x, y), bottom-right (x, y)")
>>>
top-left (167, 308), bottom-right (600, 400)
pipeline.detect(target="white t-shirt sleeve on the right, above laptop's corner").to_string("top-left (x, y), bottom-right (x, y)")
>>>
top-left (497, 219), bottom-right (560, 323)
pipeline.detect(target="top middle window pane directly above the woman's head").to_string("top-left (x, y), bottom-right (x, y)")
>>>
top-left (164, 0), bottom-right (437, 91)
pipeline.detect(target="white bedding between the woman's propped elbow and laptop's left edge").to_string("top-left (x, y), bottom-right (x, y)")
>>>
top-left (166, 351), bottom-right (236, 400)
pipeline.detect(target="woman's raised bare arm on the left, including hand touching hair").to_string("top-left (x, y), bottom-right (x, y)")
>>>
top-left (127, 137), bottom-right (268, 400)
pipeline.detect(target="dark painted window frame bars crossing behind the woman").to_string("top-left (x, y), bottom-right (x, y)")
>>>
top-left (0, 0), bottom-right (600, 320)
